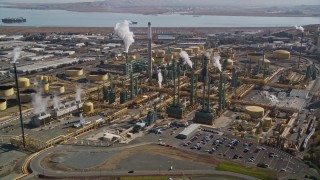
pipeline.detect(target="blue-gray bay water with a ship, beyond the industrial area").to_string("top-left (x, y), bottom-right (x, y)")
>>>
top-left (0, 7), bottom-right (320, 27)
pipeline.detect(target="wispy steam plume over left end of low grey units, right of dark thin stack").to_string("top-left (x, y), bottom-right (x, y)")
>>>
top-left (31, 91), bottom-right (50, 115)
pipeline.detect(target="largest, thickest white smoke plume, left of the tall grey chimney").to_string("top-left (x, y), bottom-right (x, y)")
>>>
top-left (114, 20), bottom-right (134, 53)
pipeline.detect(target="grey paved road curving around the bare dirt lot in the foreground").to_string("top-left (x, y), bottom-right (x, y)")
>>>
top-left (29, 143), bottom-right (257, 180)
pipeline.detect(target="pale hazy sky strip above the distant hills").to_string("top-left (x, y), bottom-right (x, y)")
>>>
top-left (0, 0), bottom-right (320, 6)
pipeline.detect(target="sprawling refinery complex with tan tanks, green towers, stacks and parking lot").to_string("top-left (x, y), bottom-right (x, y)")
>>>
top-left (0, 21), bottom-right (320, 179)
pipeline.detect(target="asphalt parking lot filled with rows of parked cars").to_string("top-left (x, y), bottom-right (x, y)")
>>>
top-left (179, 130), bottom-right (305, 173)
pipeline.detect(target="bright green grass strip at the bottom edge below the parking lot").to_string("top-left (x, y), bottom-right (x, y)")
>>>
top-left (216, 162), bottom-right (276, 180)
